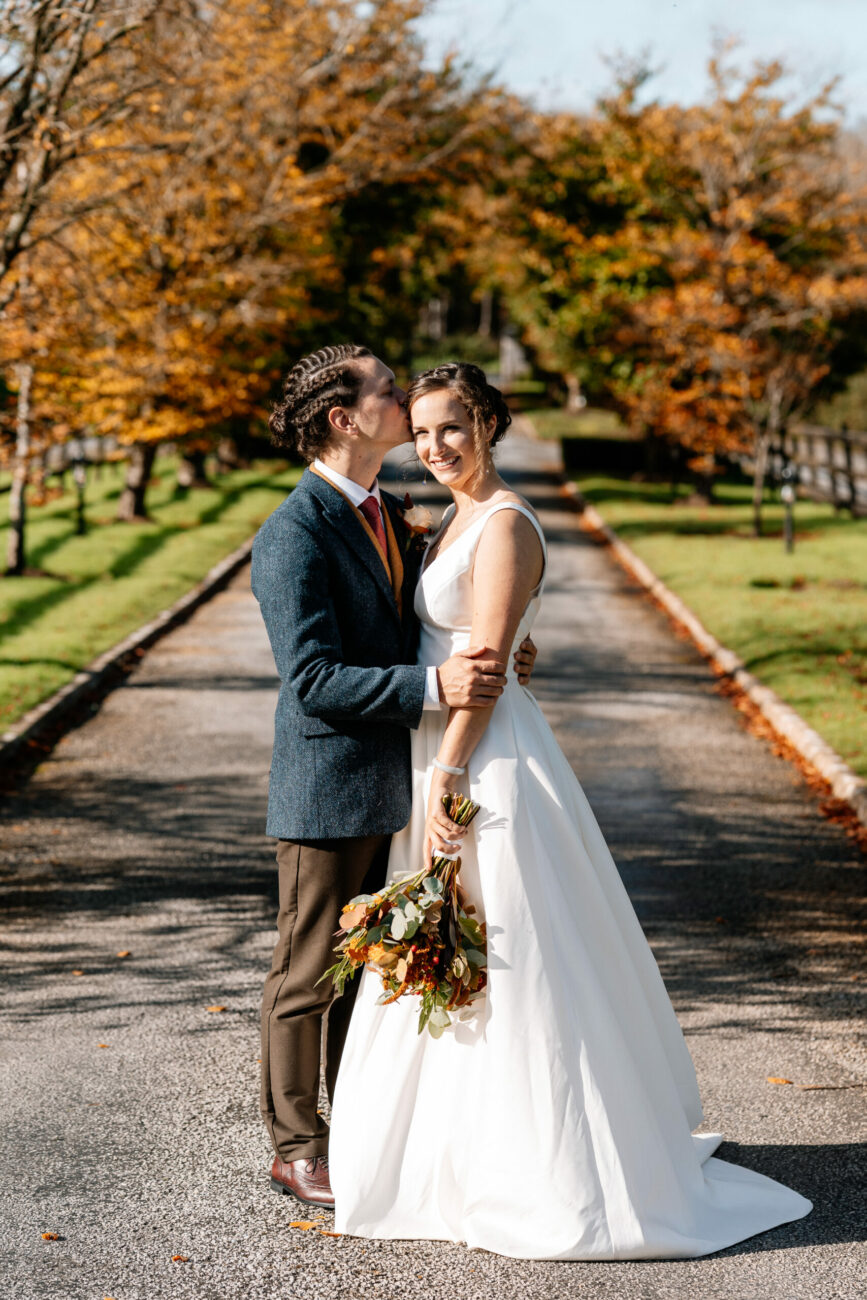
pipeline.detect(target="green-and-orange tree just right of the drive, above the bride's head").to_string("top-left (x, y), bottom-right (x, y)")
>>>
top-left (460, 68), bottom-right (682, 406)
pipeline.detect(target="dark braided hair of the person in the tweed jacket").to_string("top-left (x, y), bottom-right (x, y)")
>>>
top-left (268, 343), bottom-right (373, 463)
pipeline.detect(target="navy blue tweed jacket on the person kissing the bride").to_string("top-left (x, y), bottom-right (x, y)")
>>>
top-left (252, 469), bottom-right (425, 840)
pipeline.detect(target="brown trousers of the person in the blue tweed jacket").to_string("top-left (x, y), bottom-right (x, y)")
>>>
top-left (261, 835), bottom-right (391, 1161)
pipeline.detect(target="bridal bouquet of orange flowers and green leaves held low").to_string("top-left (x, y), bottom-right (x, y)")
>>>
top-left (322, 793), bottom-right (487, 1039)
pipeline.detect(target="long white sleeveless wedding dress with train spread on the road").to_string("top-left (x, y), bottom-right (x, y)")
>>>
top-left (329, 503), bottom-right (811, 1260)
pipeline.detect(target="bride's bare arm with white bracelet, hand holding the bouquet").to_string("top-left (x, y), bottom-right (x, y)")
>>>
top-left (424, 510), bottom-right (543, 861)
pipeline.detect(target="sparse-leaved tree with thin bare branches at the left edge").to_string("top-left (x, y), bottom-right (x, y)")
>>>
top-left (0, 0), bottom-right (184, 573)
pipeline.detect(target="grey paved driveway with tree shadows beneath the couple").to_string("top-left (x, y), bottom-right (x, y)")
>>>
top-left (0, 439), bottom-right (867, 1300)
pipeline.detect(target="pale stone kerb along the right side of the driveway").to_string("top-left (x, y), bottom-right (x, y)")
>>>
top-left (564, 482), bottom-right (867, 828)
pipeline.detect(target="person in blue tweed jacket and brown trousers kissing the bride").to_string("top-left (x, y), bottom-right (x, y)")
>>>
top-left (252, 345), bottom-right (536, 1205)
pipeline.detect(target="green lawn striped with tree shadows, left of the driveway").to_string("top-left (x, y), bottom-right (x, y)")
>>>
top-left (0, 456), bottom-right (300, 731)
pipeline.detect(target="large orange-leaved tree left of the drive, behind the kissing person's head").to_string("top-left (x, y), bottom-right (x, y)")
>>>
top-left (28, 0), bottom-right (501, 516)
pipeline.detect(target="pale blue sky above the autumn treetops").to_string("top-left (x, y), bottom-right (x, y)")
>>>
top-left (421, 0), bottom-right (867, 126)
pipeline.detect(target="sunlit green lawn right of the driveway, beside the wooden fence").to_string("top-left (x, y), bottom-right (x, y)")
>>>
top-left (576, 476), bottom-right (867, 776)
